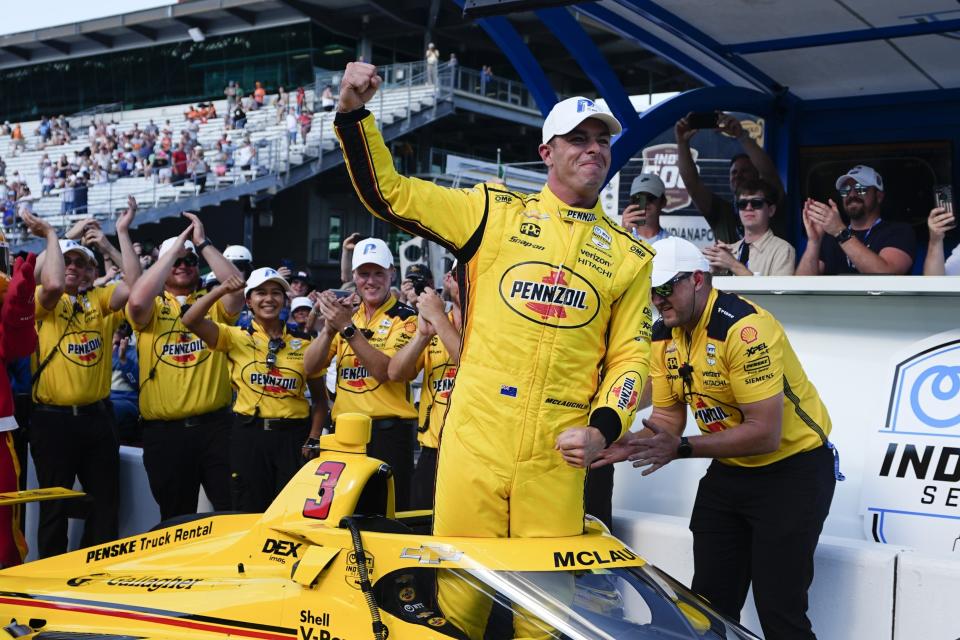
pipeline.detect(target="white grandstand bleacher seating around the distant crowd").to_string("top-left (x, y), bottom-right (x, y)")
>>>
top-left (0, 83), bottom-right (437, 228)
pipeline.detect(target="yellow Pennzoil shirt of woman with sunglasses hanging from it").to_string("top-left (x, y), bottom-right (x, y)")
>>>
top-left (214, 321), bottom-right (326, 418)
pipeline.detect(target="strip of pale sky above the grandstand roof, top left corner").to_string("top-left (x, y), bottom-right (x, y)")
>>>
top-left (0, 0), bottom-right (175, 35)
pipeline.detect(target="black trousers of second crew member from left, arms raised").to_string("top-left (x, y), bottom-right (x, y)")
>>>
top-left (143, 411), bottom-right (232, 521)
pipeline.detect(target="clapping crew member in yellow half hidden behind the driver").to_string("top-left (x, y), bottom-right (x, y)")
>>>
top-left (388, 269), bottom-right (462, 509)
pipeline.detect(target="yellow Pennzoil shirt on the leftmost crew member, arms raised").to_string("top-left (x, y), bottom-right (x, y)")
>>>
top-left (31, 284), bottom-right (123, 405)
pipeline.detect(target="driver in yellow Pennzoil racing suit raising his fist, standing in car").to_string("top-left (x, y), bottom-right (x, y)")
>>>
top-left (335, 63), bottom-right (652, 638)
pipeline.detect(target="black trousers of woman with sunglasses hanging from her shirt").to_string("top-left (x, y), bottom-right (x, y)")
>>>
top-left (230, 415), bottom-right (310, 513)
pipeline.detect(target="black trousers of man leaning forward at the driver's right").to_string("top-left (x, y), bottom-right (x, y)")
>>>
top-left (690, 447), bottom-right (836, 640)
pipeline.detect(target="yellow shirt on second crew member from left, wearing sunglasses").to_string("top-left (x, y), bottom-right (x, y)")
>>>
top-left (130, 291), bottom-right (238, 420)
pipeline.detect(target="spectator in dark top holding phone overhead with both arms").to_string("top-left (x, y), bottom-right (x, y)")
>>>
top-left (674, 113), bottom-right (784, 244)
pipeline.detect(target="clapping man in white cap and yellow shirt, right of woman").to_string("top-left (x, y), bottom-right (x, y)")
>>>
top-left (304, 238), bottom-right (417, 510)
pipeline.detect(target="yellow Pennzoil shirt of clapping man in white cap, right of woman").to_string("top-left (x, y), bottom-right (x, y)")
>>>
top-left (326, 294), bottom-right (417, 422)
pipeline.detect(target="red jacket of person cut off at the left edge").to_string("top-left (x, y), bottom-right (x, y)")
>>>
top-left (0, 253), bottom-right (37, 431)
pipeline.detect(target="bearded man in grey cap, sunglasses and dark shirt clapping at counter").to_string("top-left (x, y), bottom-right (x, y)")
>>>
top-left (796, 164), bottom-right (916, 276)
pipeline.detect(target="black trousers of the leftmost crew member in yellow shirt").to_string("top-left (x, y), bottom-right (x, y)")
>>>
top-left (30, 401), bottom-right (120, 558)
